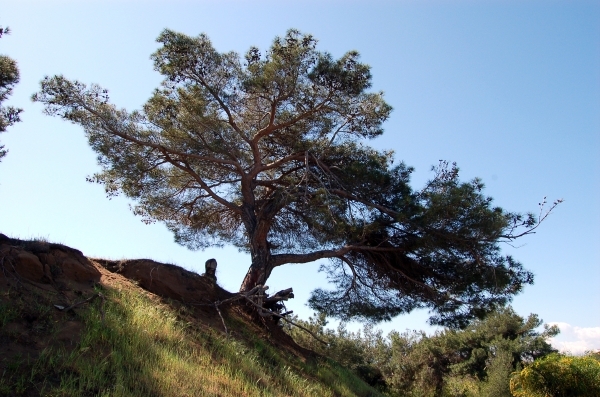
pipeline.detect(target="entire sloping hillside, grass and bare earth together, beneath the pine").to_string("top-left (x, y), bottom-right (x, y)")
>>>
top-left (0, 235), bottom-right (379, 397)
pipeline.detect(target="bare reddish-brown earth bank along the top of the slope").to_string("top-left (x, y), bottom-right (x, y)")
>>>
top-left (0, 233), bottom-right (314, 395)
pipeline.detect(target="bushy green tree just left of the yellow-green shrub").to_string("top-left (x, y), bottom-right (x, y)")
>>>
top-left (382, 307), bottom-right (559, 396)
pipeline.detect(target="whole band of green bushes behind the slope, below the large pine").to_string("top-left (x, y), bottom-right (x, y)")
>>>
top-left (289, 308), bottom-right (558, 397)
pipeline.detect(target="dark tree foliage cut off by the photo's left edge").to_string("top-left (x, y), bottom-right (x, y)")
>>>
top-left (0, 26), bottom-right (22, 161)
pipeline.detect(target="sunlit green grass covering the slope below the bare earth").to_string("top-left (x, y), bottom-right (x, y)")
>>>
top-left (0, 288), bottom-right (379, 397)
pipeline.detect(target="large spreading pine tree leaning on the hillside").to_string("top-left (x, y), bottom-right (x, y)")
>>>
top-left (33, 30), bottom-right (556, 326)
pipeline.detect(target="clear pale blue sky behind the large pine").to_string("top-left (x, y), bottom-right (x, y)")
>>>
top-left (0, 0), bottom-right (600, 348)
